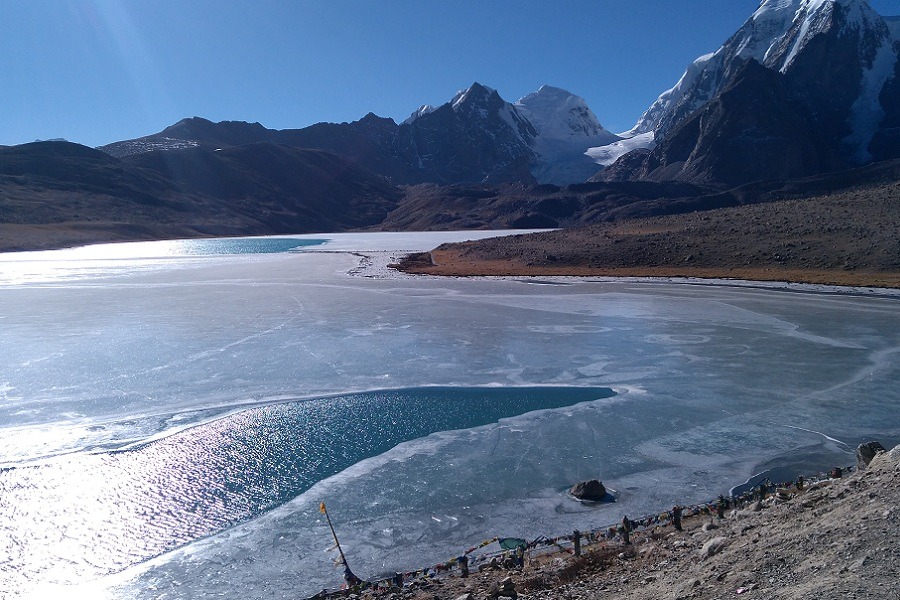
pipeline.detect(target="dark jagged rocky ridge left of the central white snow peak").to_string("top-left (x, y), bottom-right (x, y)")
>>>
top-left (100, 83), bottom-right (544, 184)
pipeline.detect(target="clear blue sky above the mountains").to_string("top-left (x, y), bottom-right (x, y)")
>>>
top-left (0, 0), bottom-right (900, 146)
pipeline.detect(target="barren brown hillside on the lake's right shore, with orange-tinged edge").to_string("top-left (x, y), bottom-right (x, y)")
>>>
top-left (401, 181), bottom-right (900, 287)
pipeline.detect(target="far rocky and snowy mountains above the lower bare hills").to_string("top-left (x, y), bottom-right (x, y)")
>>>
top-left (95, 0), bottom-right (900, 190)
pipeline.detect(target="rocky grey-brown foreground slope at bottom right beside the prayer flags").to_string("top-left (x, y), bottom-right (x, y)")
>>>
top-left (342, 446), bottom-right (900, 600)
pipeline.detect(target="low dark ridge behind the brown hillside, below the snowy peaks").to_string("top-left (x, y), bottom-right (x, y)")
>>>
top-left (378, 160), bottom-right (900, 232)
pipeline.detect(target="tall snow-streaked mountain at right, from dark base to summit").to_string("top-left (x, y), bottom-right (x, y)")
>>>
top-left (590, 0), bottom-right (900, 185)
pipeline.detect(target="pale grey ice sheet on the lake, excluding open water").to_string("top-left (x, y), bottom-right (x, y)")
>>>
top-left (0, 234), bottom-right (900, 598)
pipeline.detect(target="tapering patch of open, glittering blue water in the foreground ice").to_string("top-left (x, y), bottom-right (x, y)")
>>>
top-left (0, 387), bottom-right (613, 589)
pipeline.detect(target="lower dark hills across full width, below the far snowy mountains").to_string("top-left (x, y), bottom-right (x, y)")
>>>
top-left (0, 142), bottom-right (900, 254)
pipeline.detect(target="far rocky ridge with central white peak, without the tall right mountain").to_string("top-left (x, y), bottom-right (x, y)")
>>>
top-left (100, 83), bottom-right (619, 185)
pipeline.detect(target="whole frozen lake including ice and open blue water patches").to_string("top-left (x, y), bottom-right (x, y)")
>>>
top-left (0, 232), bottom-right (900, 599)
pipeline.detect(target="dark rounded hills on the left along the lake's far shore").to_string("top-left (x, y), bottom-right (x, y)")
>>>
top-left (0, 142), bottom-right (401, 250)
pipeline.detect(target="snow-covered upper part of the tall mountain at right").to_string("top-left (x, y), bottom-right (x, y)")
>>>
top-left (590, 0), bottom-right (898, 164)
